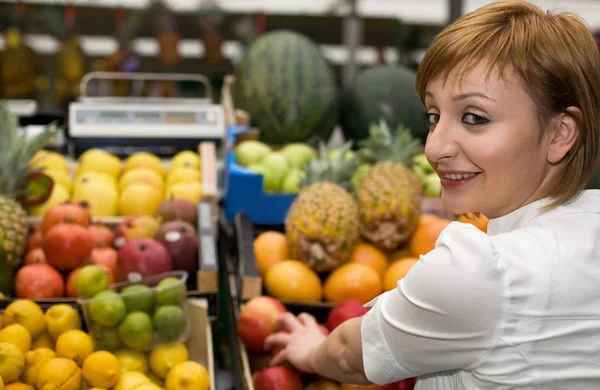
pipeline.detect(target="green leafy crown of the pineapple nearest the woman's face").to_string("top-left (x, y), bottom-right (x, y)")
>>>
top-left (358, 119), bottom-right (423, 166)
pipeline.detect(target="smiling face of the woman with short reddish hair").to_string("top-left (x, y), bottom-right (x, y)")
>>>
top-left (425, 63), bottom-right (552, 218)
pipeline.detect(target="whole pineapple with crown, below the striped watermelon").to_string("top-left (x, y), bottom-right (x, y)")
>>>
top-left (285, 144), bottom-right (359, 272)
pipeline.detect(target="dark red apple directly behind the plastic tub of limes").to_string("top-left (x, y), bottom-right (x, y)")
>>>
top-left (115, 238), bottom-right (173, 281)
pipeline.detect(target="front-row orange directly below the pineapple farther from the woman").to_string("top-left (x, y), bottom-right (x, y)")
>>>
top-left (265, 260), bottom-right (323, 302)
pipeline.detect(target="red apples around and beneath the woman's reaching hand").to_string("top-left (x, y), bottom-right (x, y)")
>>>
top-left (237, 296), bottom-right (416, 390)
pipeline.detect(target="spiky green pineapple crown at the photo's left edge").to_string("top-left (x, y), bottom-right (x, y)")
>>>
top-left (0, 102), bottom-right (59, 198)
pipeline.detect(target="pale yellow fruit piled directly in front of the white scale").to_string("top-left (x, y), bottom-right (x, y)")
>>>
top-left (28, 149), bottom-right (202, 217)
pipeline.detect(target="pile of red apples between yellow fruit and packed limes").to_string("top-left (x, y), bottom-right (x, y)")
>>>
top-left (15, 199), bottom-right (199, 299)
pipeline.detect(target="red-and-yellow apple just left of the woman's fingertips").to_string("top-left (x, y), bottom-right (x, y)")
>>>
top-left (237, 296), bottom-right (287, 353)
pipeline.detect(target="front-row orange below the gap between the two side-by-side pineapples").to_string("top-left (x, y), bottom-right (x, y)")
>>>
top-left (324, 263), bottom-right (382, 303)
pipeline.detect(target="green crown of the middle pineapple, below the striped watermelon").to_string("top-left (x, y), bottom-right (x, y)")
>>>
top-left (301, 141), bottom-right (360, 191)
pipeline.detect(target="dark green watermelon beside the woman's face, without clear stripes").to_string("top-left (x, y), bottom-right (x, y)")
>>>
top-left (340, 66), bottom-right (429, 143)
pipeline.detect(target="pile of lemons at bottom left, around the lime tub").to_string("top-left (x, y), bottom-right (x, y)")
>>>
top-left (0, 299), bottom-right (210, 390)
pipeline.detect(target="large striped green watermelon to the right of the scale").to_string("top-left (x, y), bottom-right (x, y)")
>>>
top-left (234, 30), bottom-right (338, 145)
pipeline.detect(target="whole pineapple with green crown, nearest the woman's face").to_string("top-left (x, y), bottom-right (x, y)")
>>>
top-left (355, 121), bottom-right (423, 251)
